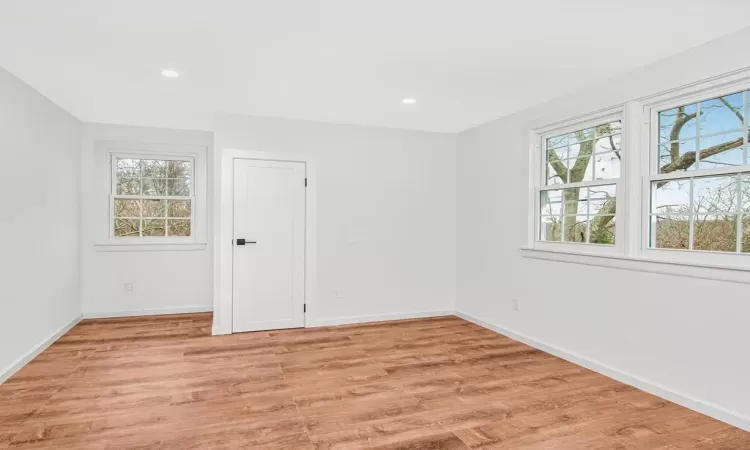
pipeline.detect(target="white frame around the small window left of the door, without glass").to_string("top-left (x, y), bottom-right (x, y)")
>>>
top-left (94, 141), bottom-right (208, 251)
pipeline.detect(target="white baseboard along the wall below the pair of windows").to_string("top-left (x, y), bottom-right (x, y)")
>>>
top-left (455, 312), bottom-right (750, 431)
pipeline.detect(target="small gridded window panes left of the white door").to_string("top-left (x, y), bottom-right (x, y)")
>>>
top-left (110, 154), bottom-right (195, 240)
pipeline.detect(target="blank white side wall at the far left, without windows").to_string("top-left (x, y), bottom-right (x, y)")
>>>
top-left (0, 68), bottom-right (81, 381)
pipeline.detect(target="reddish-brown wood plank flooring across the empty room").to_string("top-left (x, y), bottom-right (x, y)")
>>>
top-left (0, 314), bottom-right (750, 450)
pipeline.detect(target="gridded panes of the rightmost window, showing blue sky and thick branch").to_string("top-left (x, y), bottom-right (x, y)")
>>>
top-left (646, 91), bottom-right (750, 253)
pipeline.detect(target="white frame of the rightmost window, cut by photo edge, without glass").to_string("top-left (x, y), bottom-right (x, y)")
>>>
top-left (639, 77), bottom-right (750, 269)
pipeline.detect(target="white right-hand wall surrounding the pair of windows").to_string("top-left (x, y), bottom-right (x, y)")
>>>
top-left (457, 29), bottom-right (750, 427)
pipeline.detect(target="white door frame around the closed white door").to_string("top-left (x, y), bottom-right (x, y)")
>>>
top-left (212, 149), bottom-right (318, 335)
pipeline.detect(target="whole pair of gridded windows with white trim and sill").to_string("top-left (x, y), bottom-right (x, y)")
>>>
top-left (522, 70), bottom-right (750, 284)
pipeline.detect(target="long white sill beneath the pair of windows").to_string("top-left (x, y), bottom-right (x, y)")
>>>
top-left (521, 247), bottom-right (750, 284)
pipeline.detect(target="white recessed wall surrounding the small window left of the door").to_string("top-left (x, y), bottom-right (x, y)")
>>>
top-left (81, 124), bottom-right (213, 317)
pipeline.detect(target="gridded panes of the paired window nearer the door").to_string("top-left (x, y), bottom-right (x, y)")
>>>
top-left (537, 119), bottom-right (622, 245)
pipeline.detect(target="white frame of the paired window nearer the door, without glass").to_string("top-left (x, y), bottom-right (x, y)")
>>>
top-left (527, 103), bottom-right (629, 254)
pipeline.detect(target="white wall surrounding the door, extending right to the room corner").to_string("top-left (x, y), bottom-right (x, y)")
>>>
top-left (214, 116), bottom-right (456, 324)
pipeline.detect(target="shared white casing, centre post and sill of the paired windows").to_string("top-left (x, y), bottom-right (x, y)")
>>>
top-left (521, 69), bottom-right (750, 284)
